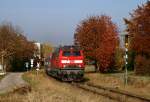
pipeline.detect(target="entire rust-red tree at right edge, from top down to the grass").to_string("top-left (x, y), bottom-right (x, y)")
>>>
top-left (125, 1), bottom-right (150, 75)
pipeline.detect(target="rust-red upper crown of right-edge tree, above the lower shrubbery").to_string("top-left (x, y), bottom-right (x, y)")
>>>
top-left (125, 1), bottom-right (150, 54)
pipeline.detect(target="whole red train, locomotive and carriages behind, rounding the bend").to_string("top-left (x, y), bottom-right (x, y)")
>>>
top-left (46, 45), bottom-right (85, 81)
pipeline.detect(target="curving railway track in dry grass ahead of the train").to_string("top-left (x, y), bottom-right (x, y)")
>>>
top-left (72, 83), bottom-right (150, 102)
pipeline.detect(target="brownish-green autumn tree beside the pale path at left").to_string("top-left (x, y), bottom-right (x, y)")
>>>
top-left (0, 23), bottom-right (34, 71)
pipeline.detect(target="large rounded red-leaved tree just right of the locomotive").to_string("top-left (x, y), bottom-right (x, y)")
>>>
top-left (75, 15), bottom-right (118, 72)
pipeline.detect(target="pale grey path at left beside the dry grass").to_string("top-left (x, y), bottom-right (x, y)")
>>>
top-left (0, 73), bottom-right (27, 94)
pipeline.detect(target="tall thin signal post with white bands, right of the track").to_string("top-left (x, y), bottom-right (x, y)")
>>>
top-left (124, 34), bottom-right (129, 85)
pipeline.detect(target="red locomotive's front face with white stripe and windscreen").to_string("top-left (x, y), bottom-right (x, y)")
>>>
top-left (60, 47), bottom-right (84, 81)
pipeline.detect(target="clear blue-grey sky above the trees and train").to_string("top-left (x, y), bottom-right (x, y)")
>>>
top-left (0, 0), bottom-right (147, 45)
